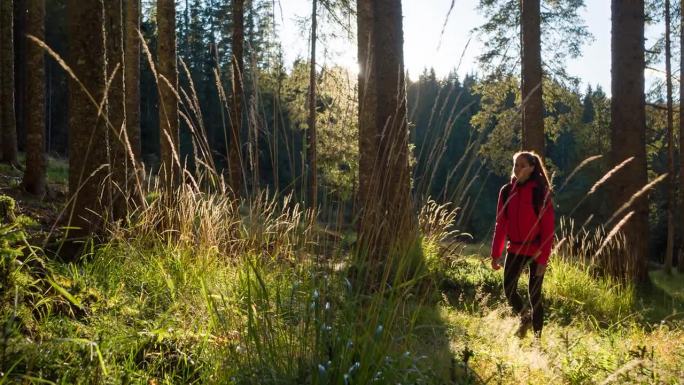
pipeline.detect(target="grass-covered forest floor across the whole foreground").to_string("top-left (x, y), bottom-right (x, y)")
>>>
top-left (0, 158), bottom-right (684, 385)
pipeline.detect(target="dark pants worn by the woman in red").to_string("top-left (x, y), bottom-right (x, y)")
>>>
top-left (504, 253), bottom-right (544, 333)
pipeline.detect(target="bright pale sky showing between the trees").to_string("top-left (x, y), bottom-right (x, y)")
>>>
top-left (277, 0), bottom-right (659, 94)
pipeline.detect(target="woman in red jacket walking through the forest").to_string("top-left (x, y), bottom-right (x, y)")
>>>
top-left (491, 151), bottom-right (554, 337)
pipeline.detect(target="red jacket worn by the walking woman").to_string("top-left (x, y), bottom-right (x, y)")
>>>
top-left (491, 178), bottom-right (554, 265)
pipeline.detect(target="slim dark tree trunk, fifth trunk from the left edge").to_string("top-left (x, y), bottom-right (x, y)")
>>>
top-left (124, 0), bottom-right (141, 167)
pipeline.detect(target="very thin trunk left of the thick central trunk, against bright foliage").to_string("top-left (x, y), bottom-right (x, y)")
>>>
top-left (306, 0), bottom-right (318, 208)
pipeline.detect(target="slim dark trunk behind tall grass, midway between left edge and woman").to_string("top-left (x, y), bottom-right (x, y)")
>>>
top-left (228, 0), bottom-right (245, 196)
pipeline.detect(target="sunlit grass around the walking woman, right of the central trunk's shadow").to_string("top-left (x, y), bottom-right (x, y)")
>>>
top-left (441, 247), bottom-right (684, 384)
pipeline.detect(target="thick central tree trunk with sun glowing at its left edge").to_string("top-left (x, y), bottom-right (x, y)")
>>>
top-left (357, 0), bottom-right (416, 290)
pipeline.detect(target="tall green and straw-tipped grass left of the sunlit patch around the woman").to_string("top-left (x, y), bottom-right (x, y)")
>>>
top-left (0, 190), bottom-right (450, 384)
